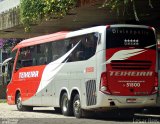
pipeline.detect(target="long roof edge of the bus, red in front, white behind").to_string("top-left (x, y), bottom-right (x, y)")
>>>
top-left (12, 24), bottom-right (153, 51)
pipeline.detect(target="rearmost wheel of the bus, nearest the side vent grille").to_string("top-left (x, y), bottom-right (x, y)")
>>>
top-left (73, 94), bottom-right (83, 118)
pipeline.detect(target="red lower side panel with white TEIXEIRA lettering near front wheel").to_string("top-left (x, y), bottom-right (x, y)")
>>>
top-left (8, 66), bottom-right (45, 105)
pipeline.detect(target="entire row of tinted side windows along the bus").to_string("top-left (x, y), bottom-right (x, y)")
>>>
top-left (16, 33), bottom-right (98, 69)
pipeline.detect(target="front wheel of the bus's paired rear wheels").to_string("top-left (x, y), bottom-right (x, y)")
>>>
top-left (60, 93), bottom-right (73, 116)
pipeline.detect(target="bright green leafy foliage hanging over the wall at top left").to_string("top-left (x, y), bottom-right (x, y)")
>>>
top-left (20, 0), bottom-right (77, 31)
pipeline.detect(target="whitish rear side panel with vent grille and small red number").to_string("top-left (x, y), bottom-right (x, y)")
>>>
top-left (81, 54), bottom-right (97, 108)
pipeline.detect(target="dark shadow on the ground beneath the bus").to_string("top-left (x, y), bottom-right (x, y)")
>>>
top-left (12, 109), bottom-right (160, 123)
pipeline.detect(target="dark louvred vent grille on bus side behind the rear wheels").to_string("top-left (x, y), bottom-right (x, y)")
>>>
top-left (86, 80), bottom-right (97, 106)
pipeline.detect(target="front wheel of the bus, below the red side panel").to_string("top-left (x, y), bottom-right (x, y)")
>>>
top-left (16, 93), bottom-right (33, 111)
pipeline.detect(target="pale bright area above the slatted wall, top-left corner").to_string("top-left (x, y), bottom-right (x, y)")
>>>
top-left (0, 0), bottom-right (20, 13)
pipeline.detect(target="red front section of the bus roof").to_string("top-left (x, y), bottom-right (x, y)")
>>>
top-left (12, 31), bottom-right (69, 51)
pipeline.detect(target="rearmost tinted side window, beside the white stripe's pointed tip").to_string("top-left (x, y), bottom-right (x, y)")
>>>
top-left (69, 33), bottom-right (98, 62)
